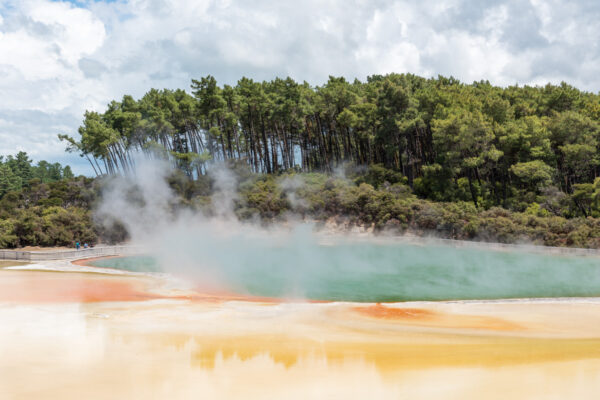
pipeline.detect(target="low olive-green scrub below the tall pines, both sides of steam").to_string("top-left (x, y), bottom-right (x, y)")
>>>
top-left (0, 159), bottom-right (600, 248)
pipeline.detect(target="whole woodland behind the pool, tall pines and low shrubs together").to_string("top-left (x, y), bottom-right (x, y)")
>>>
top-left (0, 74), bottom-right (600, 248)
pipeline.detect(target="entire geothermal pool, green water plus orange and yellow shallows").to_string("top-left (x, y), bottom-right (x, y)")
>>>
top-left (0, 240), bottom-right (600, 400)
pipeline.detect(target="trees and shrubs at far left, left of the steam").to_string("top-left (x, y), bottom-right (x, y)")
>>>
top-left (0, 152), bottom-right (98, 248)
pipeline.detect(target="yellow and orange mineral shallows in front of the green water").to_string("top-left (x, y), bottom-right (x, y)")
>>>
top-left (0, 270), bottom-right (600, 399)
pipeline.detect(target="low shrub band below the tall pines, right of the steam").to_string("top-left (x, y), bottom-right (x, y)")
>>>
top-left (220, 173), bottom-right (600, 248)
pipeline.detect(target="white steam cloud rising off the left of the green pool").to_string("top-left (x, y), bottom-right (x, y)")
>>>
top-left (96, 159), bottom-right (317, 296)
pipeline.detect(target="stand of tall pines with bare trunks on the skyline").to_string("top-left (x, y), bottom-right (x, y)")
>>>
top-left (59, 74), bottom-right (600, 216)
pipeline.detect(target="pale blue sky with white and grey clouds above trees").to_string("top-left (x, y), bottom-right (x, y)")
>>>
top-left (0, 0), bottom-right (600, 173)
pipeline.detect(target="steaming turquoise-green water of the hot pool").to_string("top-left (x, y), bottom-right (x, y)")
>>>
top-left (89, 242), bottom-right (600, 302)
